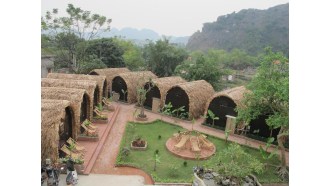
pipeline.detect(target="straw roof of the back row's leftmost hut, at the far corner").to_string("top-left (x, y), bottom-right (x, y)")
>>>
top-left (116, 71), bottom-right (157, 103)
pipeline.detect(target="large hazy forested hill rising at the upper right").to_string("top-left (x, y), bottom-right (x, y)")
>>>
top-left (186, 3), bottom-right (289, 56)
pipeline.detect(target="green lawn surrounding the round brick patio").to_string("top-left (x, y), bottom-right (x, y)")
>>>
top-left (117, 121), bottom-right (281, 183)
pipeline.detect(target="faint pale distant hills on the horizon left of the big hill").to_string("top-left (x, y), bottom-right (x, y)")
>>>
top-left (100, 27), bottom-right (189, 45)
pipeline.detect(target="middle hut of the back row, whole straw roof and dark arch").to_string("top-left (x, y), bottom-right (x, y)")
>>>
top-left (165, 80), bottom-right (214, 119)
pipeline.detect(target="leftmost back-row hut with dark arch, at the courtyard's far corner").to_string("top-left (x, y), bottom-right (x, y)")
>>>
top-left (112, 71), bottom-right (157, 103)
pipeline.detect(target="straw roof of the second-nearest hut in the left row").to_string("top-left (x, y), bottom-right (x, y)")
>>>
top-left (41, 87), bottom-right (92, 138)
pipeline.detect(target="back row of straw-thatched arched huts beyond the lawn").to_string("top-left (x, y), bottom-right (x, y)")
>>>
top-left (90, 68), bottom-right (278, 137)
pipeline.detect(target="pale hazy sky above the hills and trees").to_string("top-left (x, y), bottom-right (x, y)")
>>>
top-left (41, 0), bottom-right (289, 36)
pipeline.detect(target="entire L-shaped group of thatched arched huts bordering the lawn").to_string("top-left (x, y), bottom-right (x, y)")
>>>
top-left (41, 68), bottom-right (276, 161)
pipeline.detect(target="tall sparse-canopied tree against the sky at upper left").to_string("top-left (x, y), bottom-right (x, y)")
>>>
top-left (41, 4), bottom-right (111, 71)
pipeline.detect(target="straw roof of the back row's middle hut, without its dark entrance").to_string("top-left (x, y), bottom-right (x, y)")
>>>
top-left (169, 80), bottom-right (214, 119)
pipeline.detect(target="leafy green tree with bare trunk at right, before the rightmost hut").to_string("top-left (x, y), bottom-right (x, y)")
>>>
top-left (237, 47), bottom-right (289, 178)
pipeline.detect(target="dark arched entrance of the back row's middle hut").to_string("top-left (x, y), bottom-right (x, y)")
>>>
top-left (165, 87), bottom-right (189, 115)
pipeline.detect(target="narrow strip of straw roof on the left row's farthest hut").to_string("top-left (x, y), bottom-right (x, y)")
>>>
top-left (47, 73), bottom-right (108, 103)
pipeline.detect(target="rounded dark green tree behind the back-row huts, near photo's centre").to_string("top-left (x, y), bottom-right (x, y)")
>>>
top-left (143, 38), bottom-right (188, 77)
